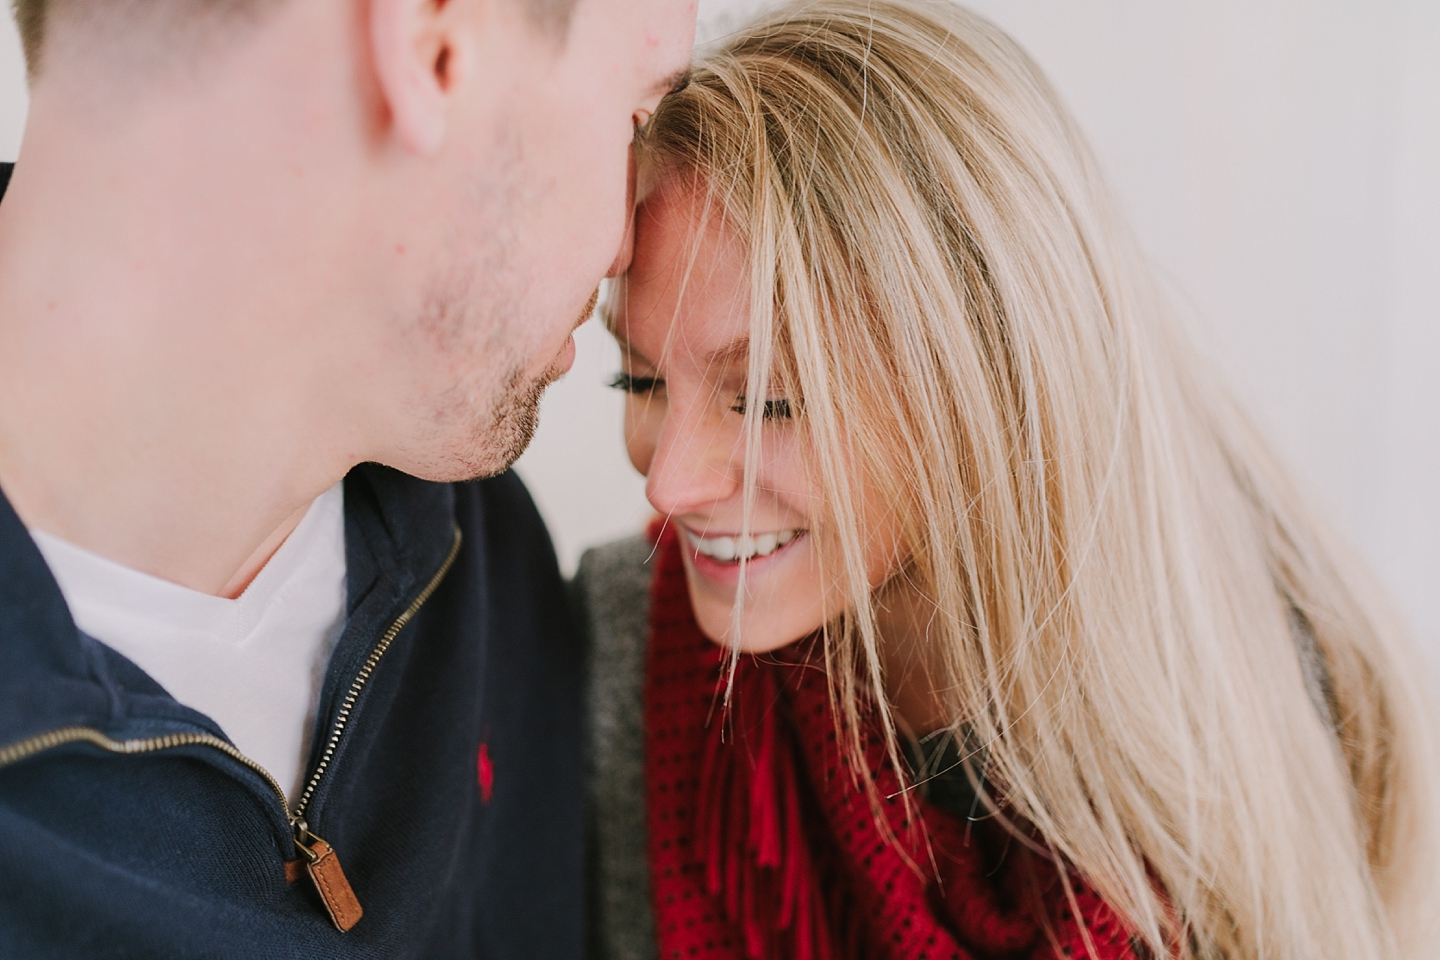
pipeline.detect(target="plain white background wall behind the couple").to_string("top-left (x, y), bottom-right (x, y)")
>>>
top-left (0, 0), bottom-right (1440, 659)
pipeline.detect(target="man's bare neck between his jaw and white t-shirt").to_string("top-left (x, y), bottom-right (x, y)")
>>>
top-left (0, 73), bottom-right (369, 596)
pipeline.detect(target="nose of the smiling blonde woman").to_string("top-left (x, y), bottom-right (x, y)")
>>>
top-left (645, 409), bottom-right (744, 515)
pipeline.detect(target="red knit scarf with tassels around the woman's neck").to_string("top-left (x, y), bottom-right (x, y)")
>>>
top-left (645, 531), bottom-right (1139, 960)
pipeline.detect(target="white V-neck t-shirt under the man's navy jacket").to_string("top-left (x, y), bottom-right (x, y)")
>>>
top-left (30, 484), bottom-right (346, 800)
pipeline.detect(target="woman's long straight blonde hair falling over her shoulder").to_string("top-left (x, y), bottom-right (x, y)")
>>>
top-left (642, 0), bottom-right (1440, 960)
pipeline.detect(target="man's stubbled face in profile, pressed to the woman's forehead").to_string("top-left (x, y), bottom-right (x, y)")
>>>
top-left (390, 0), bottom-right (696, 481)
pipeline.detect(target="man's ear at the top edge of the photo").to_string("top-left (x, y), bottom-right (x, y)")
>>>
top-left (370, 0), bottom-right (459, 157)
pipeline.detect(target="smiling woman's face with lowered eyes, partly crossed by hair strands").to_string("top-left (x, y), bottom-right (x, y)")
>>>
top-left (611, 180), bottom-right (899, 652)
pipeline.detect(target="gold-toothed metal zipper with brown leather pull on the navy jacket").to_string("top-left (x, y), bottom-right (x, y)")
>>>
top-left (0, 527), bottom-right (461, 933)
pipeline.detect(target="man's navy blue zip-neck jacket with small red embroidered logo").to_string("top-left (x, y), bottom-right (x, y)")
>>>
top-left (0, 454), bottom-right (583, 960)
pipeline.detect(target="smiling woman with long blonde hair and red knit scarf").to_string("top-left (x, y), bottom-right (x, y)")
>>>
top-left (580, 0), bottom-right (1437, 960)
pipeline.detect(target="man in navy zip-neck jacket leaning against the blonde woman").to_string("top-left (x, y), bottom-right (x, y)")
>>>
top-left (0, 0), bottom-right (694, 959)
